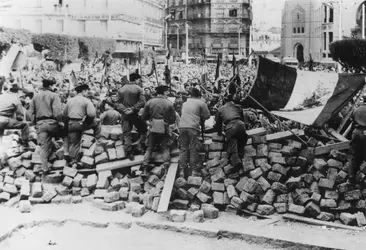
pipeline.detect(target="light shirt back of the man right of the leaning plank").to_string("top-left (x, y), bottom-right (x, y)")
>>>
top-left (179, 98), bottom-right (210, 130)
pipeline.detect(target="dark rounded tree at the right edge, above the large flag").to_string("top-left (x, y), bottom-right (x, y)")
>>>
top-left (329, 38), bottom-right (366, 73)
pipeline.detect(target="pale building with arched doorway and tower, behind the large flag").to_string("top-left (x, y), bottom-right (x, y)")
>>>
top-left (281, 0), bottom-right (364, 63)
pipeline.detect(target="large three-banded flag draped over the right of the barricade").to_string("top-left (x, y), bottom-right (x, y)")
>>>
top-left (246, 57), bottom-right (366, 127)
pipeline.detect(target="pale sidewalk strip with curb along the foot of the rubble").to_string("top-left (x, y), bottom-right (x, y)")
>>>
top-left (0, 202), bottom-right (366, 250)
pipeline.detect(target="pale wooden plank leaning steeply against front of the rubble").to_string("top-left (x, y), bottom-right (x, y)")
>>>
top-left (157, 163), bottom-right (178, 213)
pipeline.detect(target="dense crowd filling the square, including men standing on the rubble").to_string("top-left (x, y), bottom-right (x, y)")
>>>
top-left (0, 53), bottom-right (358, 182)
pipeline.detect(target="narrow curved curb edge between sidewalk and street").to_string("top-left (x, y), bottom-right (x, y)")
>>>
top-left (0, 219), bottom-right (339, 250)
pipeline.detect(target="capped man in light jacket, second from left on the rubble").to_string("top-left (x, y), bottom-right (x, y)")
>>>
top-left (29, 79), bottom-right (62, 174)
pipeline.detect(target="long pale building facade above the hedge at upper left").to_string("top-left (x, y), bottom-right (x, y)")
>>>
top-left (0, 0), bottom-right (165, 53)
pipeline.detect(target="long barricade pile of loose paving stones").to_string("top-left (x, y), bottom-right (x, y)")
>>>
top-left (0, 126), bottom-right (366, 226)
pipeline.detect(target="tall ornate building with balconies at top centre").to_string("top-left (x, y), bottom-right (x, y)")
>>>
top-left (166, 0), bottom-right (252, 56)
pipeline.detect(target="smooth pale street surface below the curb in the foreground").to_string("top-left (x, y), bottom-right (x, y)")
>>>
top-left (0, 222), bottom-right (271, 250)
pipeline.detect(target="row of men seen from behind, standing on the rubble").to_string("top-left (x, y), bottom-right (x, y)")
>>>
top-left (0, 65), bottom-right (252, 182)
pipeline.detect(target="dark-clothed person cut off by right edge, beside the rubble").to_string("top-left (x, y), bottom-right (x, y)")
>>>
top-left (348, 95), bottom-right (366, 183)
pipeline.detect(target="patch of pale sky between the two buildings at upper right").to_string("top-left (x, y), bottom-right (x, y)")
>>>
top-left (253, 0), bottom-right (285, 29)
